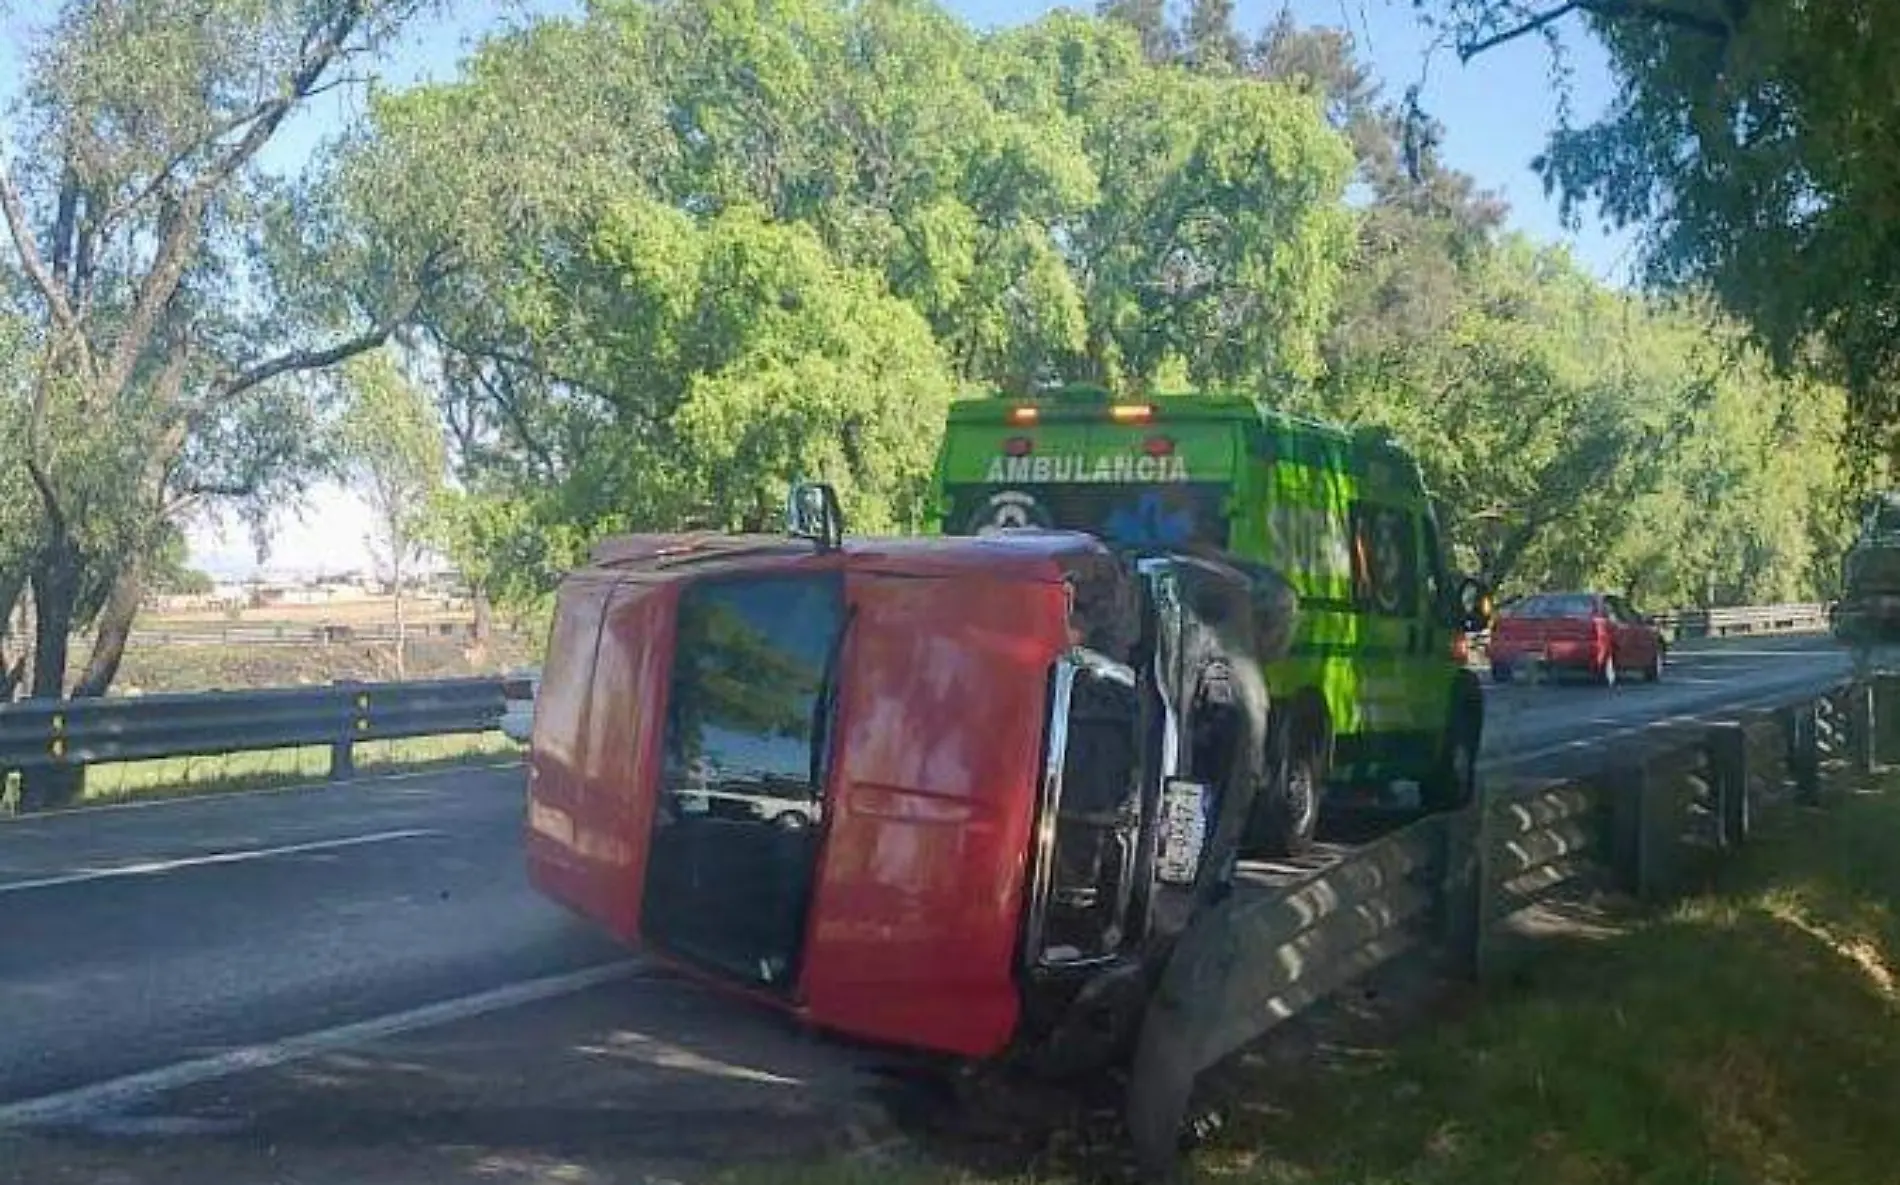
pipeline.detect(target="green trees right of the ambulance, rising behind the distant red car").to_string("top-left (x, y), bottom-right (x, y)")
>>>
top-left (1250, 19), bottom-right (1851, 606)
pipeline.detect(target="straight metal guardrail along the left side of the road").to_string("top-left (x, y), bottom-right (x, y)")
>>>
top-left (0, 678), bottom-right (526, 779)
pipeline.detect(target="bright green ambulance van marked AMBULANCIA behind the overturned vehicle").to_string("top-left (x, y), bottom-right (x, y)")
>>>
top-left (935, 387), bottom-right (1490, 851)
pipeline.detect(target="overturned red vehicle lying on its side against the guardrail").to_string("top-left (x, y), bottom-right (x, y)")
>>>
top-left (526, 488), bottom-right (1292, 1063)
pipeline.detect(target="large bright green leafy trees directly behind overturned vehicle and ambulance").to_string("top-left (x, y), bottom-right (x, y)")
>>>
top-left (359, 0), bottom-right (1351, 610)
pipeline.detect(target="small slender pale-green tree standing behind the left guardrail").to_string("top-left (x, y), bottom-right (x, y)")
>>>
top-left (340, 349), bottom-right (448, 678)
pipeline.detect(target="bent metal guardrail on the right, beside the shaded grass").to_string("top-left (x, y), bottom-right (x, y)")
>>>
top-left (1127, 676), bottom-right (1877, 1179)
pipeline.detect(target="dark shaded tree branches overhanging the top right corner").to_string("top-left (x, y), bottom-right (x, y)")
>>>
top-left (1414, 0), bottom-right (1900, 450)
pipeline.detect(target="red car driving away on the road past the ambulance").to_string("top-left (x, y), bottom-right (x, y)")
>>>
top-left (1490, 593), bottom-right (1668, 686)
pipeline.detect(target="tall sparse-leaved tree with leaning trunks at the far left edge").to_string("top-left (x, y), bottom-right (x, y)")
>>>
top-left (0, 0), bottom-right (443, 744)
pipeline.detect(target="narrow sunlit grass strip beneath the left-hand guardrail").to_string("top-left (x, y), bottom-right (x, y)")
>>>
top-left (0, 733), bottom-right (523, 815)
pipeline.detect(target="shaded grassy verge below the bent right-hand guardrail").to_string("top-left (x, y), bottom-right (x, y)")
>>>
top-left (732, 779), bottom-right (1900, 1185)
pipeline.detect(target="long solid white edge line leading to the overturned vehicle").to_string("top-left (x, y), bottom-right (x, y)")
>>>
top-left (0, 959), bottom-right (648, 1128)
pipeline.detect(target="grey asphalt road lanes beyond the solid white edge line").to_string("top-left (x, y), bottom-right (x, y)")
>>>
top-left (0, 638), bottom-right (1847, 1126)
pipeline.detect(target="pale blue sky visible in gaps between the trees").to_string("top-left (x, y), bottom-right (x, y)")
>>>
top-left (0, 0), bottom-right (1634, 575)
